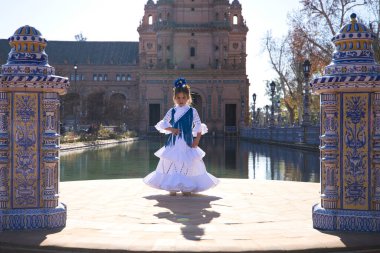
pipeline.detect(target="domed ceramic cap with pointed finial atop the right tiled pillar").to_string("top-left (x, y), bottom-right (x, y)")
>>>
top-left (311, 13), bottom-right (380, 94)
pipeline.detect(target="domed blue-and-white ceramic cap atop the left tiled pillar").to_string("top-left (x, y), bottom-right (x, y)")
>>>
top-left (0, 25), bottom-right (69, 94)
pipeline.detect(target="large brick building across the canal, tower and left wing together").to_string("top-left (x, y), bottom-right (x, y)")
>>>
top-left (0, 0), bottom-right (249, 133)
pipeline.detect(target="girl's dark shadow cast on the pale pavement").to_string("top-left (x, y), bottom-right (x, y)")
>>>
top-left (145, 194), bottom-right (220, 241)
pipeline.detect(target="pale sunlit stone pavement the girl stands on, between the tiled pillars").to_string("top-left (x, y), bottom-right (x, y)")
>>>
top-left (0, 179), bottom-right (380, 253)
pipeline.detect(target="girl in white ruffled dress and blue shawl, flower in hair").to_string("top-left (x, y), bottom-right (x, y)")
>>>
top-left (144, 78), bottom-right (219, 196)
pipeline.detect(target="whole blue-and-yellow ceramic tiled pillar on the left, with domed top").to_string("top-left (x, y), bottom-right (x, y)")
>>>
top-left (0, 26), bottom-right (69, 231)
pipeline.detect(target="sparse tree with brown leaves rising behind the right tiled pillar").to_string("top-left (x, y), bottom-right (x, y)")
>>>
top-left (264, 0), bottom-right (374, 123)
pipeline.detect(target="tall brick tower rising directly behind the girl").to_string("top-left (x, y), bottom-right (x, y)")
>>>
top-left (138, 0), bottom-right (249, 134)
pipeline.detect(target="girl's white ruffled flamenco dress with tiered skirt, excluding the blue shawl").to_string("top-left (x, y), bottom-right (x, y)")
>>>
top-left (143, 105), bottom-right (219, 192)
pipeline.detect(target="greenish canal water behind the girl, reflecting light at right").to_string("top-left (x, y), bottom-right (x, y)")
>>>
top-left (60, 137), bottom-right (320, 182)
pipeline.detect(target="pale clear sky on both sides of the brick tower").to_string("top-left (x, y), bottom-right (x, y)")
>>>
top-left (0, 0), bottom-right (300, 108)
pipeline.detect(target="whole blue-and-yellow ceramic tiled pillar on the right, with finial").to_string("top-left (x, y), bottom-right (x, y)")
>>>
top-left (311, 14), bottom-right (380, 232)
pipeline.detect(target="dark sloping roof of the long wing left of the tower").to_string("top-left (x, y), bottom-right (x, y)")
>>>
top-left (0, 39), bottom-right (139, 66)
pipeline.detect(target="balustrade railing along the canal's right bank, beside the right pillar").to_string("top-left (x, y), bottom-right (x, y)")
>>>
top-left (240, 126), bottom-right (320, 147)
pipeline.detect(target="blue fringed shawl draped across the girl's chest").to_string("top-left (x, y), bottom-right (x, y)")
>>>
top-left (165, 107), bottom-right (193, 147)
